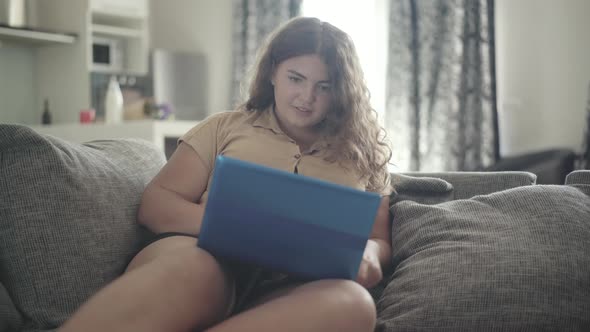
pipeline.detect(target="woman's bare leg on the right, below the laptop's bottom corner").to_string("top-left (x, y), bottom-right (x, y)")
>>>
top-left (207, 280), bottom-right (376, 332)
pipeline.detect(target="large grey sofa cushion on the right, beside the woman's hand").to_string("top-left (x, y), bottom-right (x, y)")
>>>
top-left (377, 185), bottom-right (590, 331)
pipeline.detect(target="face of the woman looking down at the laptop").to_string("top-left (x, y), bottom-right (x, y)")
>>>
top-left (272, 54), bottom-right (332, 140)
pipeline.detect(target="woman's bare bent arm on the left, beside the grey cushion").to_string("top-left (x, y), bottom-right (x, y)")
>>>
top-left (137, 143), bottom-right (209, 235)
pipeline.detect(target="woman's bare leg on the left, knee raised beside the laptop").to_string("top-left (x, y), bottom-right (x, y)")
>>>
top-left (60, 236), bottom-right (233, 332)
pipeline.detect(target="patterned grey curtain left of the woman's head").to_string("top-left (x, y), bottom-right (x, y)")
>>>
top-left (231, 0), bottom-right (302, 105)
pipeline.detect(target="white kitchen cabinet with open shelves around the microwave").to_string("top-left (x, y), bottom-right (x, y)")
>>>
top-left (24, 0), bottom-right (149, 124)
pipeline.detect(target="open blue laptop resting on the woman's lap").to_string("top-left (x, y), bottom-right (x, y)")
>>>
top-left (198, 156), bottom-right (380, 280)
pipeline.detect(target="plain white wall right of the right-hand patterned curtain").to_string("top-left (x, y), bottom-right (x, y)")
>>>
top-left (496, 0), bottom-right (590, 156)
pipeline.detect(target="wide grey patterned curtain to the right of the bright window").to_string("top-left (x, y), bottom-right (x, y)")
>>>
top-left (385, 0), bottom-right (499, 171)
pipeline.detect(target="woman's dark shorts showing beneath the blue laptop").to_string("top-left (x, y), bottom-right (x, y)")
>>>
top-left (143, 232), bottom-right (306, 315)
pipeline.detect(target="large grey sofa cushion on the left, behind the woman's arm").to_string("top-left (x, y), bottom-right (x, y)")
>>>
top-left (0, 125), bottom-right (165, 330)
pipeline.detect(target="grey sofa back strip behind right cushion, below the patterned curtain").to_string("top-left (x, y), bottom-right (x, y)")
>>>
top-left (404, 172), bottom-right (537, 199)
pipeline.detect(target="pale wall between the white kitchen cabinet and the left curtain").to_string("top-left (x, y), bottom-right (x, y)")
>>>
top-left (151, 0), bottom-right (232, 114)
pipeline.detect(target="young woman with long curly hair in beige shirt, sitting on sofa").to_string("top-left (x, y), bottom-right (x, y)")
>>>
top-left (62, 18), bottom-right (391, 332)
